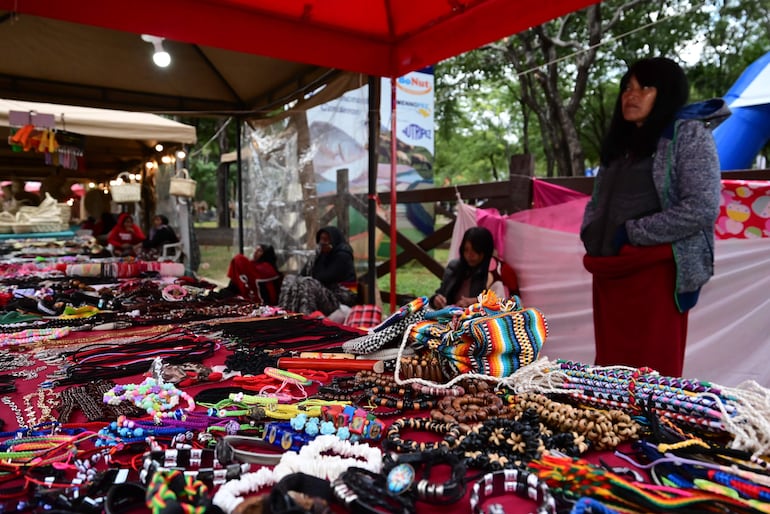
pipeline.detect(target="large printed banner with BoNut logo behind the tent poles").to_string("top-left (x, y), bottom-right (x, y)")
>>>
top-left (307, 69), bottom-right (435, 248)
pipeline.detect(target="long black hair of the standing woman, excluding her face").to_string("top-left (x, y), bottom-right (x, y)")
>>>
top-left (601, 57), bottom-right (690, 166)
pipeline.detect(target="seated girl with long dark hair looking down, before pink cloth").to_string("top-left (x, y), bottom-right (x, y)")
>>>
top-left (430, 227), bottom-right (518, 309)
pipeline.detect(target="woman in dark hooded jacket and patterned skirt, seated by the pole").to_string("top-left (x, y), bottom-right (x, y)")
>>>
top-left (278, 227), bottom-right (356, 316)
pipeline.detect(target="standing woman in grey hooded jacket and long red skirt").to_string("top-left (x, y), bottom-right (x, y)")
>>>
top-left (580, 57), bottom-right (729, 376)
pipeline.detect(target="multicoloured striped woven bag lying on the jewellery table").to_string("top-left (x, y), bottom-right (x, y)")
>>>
top-left (438, 308), bottom-right (548, 378)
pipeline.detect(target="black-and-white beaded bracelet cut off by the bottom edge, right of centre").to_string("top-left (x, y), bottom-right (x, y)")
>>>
top-left (470, 469), bottom-right (556, 514)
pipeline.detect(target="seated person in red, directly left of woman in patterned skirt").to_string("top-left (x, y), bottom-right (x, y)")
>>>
top-left (220, 244), bottom-right (283, 305)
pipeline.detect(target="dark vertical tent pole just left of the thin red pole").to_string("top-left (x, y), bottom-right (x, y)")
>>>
top-left (366, 75), bottom-right (381, 305)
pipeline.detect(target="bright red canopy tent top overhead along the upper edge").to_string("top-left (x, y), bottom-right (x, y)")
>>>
top-left (0, 0), bottom-right (596, 77)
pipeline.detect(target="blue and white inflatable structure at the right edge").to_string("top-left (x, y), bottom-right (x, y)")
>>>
top-left (714, 52), bottom-right (770, 170)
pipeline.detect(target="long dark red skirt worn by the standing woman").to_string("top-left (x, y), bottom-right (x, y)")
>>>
top-left (583, 245), bottom-right (687, 377)
